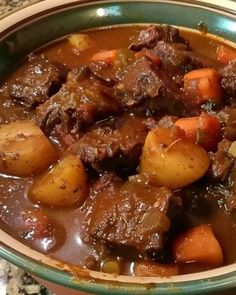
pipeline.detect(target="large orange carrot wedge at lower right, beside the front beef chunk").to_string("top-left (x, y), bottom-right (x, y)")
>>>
top-left (173, 224), bottom-right (223, 265)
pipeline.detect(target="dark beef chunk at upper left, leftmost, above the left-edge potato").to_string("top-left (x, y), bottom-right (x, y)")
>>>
top-left (9, 56), bottom-right (68, 107)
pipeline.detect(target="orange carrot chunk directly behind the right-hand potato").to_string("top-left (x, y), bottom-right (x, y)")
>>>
top-left (175, 114), bottom-right (221, 151)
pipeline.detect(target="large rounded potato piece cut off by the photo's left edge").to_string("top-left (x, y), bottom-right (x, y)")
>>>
top-left (0, 120), bottom-right (57, 176)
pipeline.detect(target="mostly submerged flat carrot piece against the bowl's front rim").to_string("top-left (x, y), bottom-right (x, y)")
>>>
top-left (134, 262), bottom-right (178, 277)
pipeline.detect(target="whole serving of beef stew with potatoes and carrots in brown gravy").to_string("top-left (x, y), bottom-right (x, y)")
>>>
top-left (0, 26), bottom-right (236, 276)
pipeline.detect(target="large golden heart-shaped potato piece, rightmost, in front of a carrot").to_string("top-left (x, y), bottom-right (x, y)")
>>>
top-left (140, 128), bottom-right (210, 189)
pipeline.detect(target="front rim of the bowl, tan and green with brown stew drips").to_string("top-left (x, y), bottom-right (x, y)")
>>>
top-left (0, 229), bottom-right (236, 295)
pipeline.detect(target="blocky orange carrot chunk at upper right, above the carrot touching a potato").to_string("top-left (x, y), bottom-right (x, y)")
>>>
top-left (184, 68), bottom-right (221, 104)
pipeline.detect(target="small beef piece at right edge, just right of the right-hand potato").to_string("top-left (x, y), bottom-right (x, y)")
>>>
top-left (210, 139), bottom-right (234, 182)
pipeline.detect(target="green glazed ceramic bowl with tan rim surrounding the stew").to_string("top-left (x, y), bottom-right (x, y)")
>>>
top-left (0, 0), bottom-right (236, 295)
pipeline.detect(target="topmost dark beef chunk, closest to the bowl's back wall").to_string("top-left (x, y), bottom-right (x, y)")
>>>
top-left (129, 25), bottom-right (186, 51)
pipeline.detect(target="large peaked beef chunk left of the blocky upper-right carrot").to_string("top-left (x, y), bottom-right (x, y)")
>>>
top-left (115, 56), bottom-right (193, 114)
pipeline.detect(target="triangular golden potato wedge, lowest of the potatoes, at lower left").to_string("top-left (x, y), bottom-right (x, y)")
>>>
top-left (29, 155), bottom-right (88, 207)
